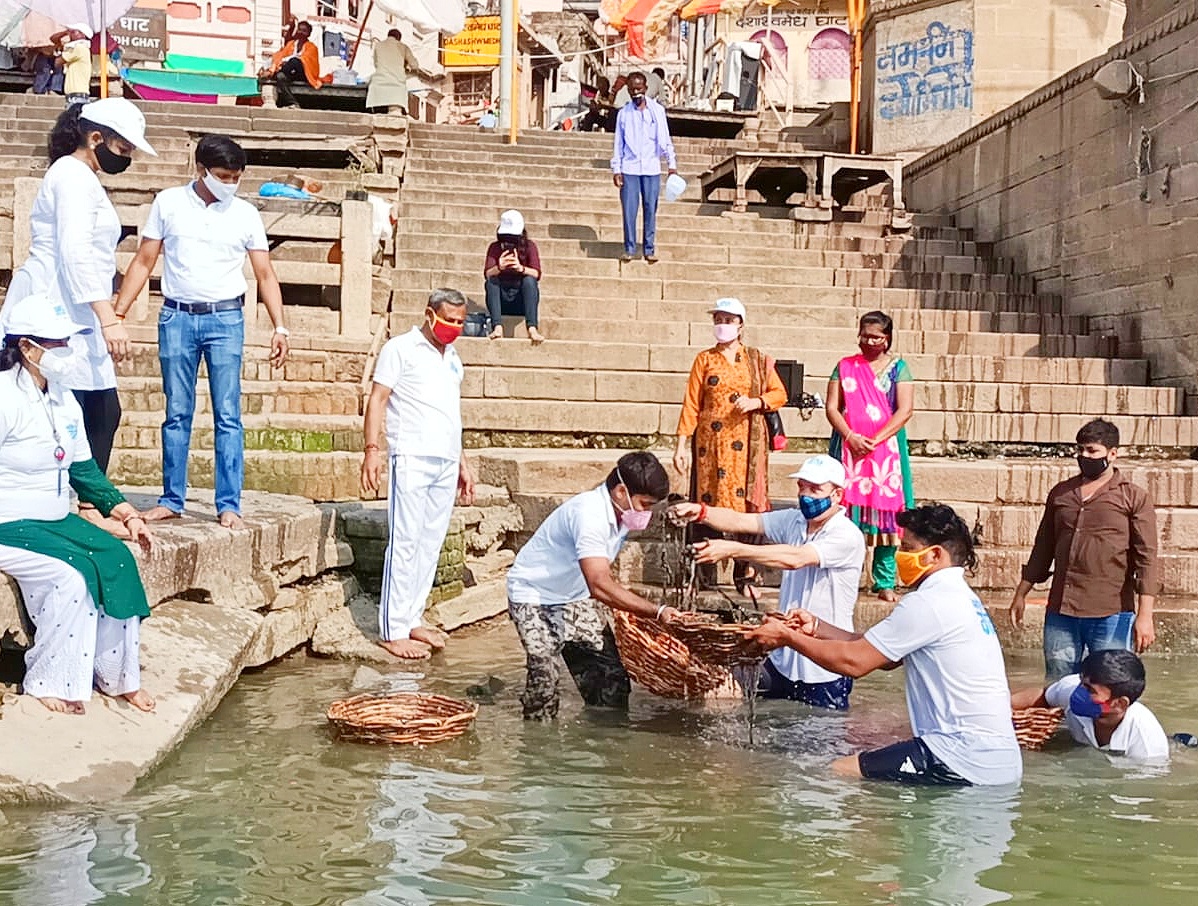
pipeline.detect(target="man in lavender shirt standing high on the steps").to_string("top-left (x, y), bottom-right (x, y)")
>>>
top-left (611, 72), bottom-right (678, 264)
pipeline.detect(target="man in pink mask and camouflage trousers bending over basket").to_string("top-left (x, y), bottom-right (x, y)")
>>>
top-left (508, 451), bottom-right (677, 720)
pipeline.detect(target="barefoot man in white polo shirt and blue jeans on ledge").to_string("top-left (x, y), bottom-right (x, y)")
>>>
top-left (115, 135), bottom-right (290, 529)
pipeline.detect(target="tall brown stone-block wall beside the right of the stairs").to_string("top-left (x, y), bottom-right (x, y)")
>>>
top-left (903, 0), bottom-right (1198, 391)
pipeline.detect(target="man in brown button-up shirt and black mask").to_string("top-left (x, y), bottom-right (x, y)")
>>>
top-left (1010, 418), bottom-right (1160, 681)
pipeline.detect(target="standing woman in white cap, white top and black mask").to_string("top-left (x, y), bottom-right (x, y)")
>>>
top-left (8, 97), bottom-right (155, 529)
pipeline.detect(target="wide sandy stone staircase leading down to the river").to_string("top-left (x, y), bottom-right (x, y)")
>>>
top-left (0, 106), bottom-right (1198, 606)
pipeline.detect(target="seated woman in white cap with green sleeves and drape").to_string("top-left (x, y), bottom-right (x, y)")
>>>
top-left (0, 294), bottom-right (155, 714)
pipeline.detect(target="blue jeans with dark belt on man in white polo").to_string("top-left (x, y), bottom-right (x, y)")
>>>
top-left (158, 308), bottom-right (246, 514)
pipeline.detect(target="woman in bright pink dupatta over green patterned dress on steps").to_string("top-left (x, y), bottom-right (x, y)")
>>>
top-left (827, 312), bottom-right (915, 602)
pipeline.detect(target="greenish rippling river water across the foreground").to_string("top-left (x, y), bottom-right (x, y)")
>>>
top-left (0, 623), bottom-right (1198, 906)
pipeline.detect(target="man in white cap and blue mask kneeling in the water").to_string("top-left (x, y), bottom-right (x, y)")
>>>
top-left (672, 454), bottom-right (865, 711)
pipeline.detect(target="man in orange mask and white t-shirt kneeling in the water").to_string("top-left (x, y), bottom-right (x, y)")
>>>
top-left (752, 503), bottom-right (1023, 786)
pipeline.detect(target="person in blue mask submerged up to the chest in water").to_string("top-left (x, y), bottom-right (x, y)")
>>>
top-left (1011, 648), bottom-right (1169, 762)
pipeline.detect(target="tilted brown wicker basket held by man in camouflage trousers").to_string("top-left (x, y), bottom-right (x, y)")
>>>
top-left (611, 610), bottom-right (732, 699)
